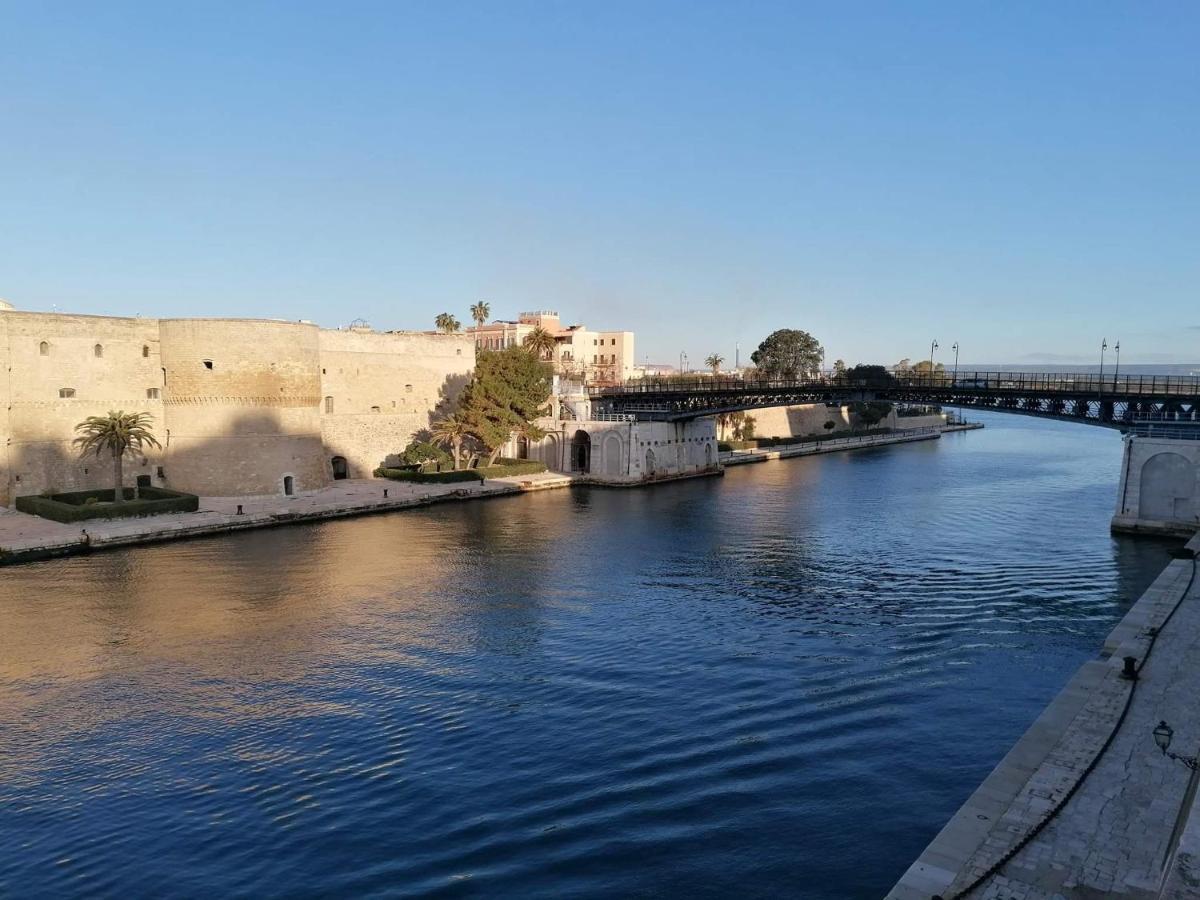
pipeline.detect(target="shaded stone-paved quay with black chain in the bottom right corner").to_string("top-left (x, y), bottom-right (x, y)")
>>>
top-left (888, 535), bottom-right (1200, 900)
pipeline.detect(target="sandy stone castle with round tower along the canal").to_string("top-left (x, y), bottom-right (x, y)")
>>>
top-left (0, 304), bottom-right (475, 505)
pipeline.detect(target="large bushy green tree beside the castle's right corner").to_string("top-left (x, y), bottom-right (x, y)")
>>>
top-left (458, 347), bottom-right (553, 464)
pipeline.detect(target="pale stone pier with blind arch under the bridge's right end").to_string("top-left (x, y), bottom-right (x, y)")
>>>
top-left (1112, 431), bottom-right (1200, 535)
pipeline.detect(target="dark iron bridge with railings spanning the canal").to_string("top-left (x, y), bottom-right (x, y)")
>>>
top-left (589, 372), bottom-right (1200, 430)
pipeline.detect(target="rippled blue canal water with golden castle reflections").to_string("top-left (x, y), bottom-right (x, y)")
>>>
top-left (0, 415), bottom-right (1170, 899)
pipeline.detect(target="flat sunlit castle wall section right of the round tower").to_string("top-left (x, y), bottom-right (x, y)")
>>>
top-left (320, 331), bottom-right (475, 478)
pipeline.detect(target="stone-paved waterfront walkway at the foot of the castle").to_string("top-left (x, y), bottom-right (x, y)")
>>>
top-left (0, 472), bottom-right (572, 563)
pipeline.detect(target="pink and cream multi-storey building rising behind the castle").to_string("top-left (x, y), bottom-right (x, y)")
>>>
top-left (469, 310), bottom-right (635, 384)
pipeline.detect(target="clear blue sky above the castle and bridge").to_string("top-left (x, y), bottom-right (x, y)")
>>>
top-left (0, 0), bottom-right (1200, 366)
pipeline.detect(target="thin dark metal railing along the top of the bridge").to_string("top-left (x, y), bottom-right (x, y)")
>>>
top-left (588, 371), bottom-right (1200, 397)
